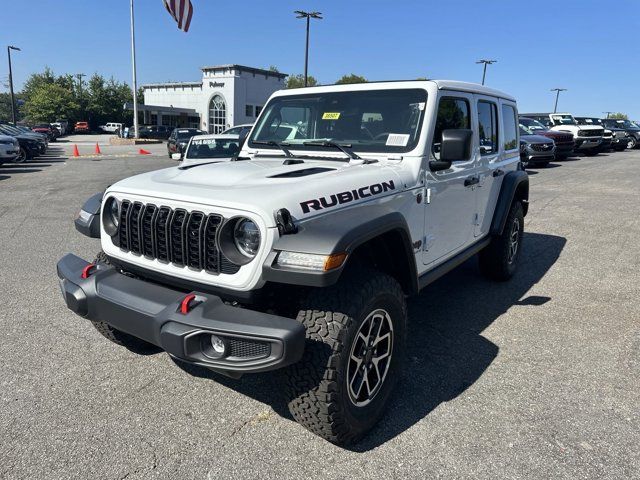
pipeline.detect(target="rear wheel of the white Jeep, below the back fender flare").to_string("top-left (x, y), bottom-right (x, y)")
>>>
top-left (478, 200), bottom-right (524, 282)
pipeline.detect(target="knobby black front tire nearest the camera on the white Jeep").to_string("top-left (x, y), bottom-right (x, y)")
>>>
top-left (281, 268), bottom-right (407, 445)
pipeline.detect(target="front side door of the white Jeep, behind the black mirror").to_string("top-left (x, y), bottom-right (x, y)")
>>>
top-left (423, 92), bottom-right (477, 265)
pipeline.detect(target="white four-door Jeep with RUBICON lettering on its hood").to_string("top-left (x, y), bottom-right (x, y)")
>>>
top-left (57, 81), bottom-right (529, 444)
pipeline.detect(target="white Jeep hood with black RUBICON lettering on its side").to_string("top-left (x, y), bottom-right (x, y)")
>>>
top-left (108, 158), bottom-right (404, 227)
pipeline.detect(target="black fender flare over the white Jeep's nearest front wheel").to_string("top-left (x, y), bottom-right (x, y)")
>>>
top-left (262, 205), bottom-right (418, 293)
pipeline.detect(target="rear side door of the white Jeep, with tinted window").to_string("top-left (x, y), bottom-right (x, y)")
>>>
top-left (473, 95), bottom-right (505, 237)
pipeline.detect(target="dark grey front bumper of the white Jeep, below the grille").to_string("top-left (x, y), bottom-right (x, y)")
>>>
top-left (57, 254), bottom-right (305, 376)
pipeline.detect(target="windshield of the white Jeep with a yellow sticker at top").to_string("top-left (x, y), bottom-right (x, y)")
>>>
top-left (249, 89), bottom-right (427, 152)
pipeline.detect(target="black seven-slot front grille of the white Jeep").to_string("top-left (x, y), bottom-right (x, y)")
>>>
top-left (113, 200), bottom-right (240, 275)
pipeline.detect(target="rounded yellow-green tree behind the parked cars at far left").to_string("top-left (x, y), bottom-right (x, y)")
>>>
top-left (24, 83), bottom-right (78, 123)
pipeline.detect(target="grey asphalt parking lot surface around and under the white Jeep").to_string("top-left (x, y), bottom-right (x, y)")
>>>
top-left (0, 148), bottom-right (640, 479)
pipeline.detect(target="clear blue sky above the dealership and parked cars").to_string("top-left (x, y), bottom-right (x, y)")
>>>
top-left (0, 0), bottom-right (640, 120)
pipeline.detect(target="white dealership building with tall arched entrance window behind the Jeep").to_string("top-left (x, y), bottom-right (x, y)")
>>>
top-left (138, 65), bottom-right (287, 133)
